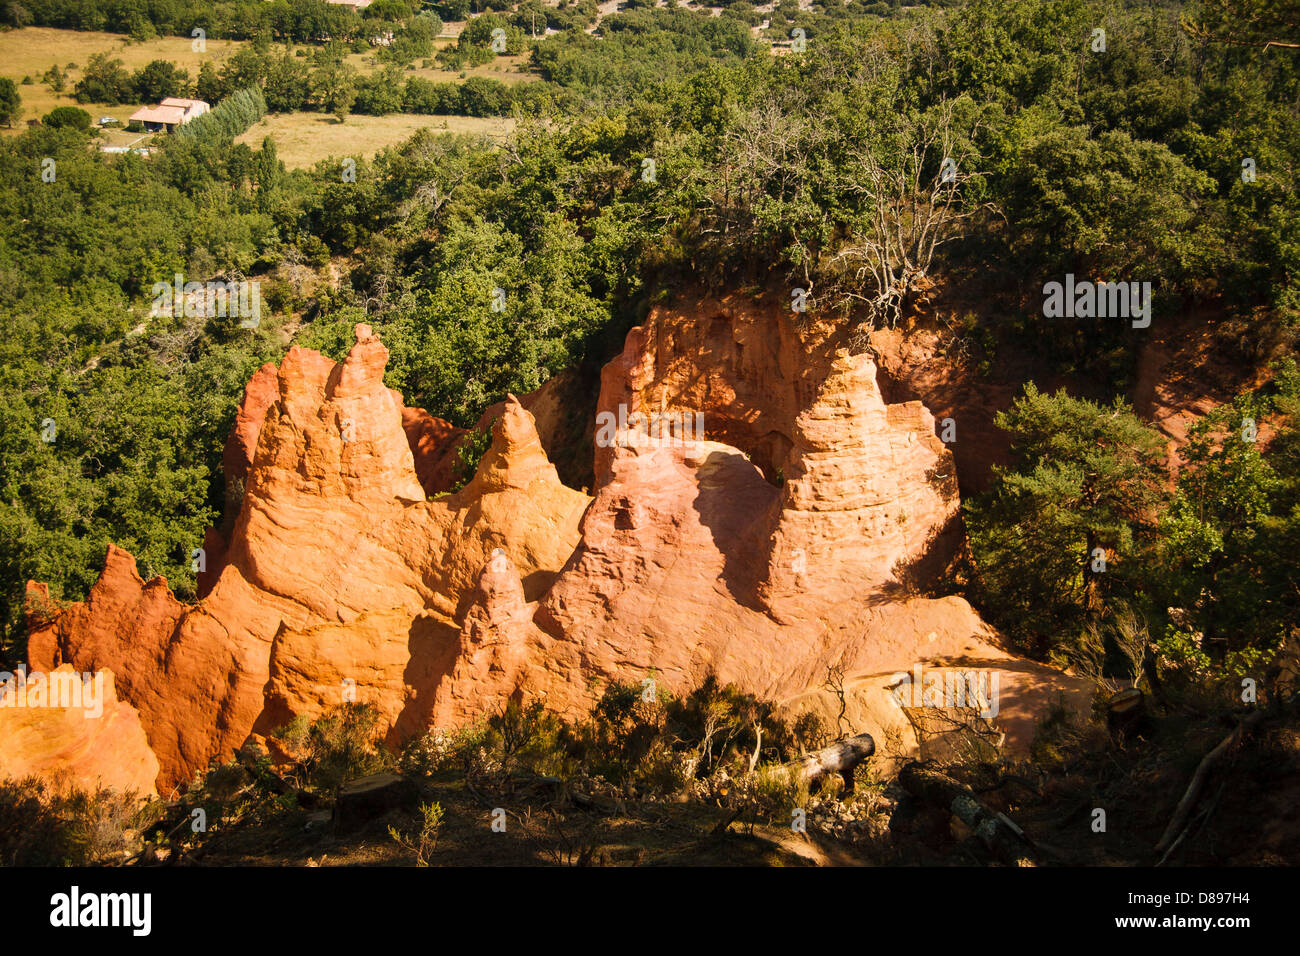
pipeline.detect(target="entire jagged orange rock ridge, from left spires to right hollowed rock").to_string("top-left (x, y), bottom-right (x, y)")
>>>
top-left (29, 302), bottom-right (1092, 788)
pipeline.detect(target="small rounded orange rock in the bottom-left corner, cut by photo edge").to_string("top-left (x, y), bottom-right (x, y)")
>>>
top-left (0, 665), bottom-right (159, 796)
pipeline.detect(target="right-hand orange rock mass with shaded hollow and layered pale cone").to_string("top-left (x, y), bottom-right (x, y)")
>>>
top-left (530, 297), bottom-right (1086, 745)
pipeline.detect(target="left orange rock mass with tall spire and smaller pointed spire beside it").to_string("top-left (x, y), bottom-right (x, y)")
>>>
top-left (29, 325), bottom-right (588, 790)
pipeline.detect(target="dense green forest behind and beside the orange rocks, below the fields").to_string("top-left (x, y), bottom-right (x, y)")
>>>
top-left (0, 0), bottom-right (1300, 702)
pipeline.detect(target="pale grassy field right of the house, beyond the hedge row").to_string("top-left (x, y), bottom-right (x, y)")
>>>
top-left (235, 113), bottom-right (515, 169)
